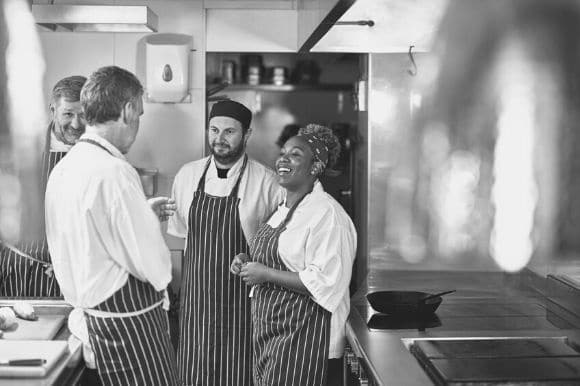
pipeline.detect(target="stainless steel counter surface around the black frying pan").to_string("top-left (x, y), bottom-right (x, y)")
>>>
top-left (347, 272), bottom-right (580, 386)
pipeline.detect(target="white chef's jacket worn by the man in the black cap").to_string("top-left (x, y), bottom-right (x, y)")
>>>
top-left (167, 157), bottom-right (284, 245)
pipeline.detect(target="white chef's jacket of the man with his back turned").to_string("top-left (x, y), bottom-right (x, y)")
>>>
top-left (45, 133), bottom-right (171, 308)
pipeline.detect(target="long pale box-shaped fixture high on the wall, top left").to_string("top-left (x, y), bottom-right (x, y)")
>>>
top-left (32, 4), bottom-right (158, 32)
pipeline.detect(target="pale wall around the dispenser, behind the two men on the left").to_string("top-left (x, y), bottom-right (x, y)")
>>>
top-left (35, 0), bottom-right (205, 258)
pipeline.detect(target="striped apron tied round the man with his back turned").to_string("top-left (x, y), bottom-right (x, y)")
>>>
top-left (85, 275), bottom-right (179, 386)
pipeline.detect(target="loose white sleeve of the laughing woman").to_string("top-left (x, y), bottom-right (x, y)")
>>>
top-left (298, 211), bottom-right (356, 312)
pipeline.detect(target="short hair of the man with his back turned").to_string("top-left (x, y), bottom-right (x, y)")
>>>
top-left (81, 66), bottom-right (143, 125)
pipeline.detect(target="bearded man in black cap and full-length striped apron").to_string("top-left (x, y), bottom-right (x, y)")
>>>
top-left (167, 101), bottom-right (282, 386)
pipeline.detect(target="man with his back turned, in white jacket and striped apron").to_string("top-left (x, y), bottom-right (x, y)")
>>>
top-left (46, 66), bottom-right (178, 385)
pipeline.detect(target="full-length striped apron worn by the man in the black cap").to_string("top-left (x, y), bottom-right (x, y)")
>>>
top-left (177, 156), bottom-right (252, 386)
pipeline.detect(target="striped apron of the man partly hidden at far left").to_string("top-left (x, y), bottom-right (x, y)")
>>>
top-left (0, 123), bottom-right (67, 297)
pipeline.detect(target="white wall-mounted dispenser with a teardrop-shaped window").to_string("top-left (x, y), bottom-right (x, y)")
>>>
top-left (145, 34), bottom-right (192, 103)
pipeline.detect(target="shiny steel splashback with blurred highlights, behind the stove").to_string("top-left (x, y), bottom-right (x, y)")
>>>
top-left (366, 38), bottom-right (580, 276)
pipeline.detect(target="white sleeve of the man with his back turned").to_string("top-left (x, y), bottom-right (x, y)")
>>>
top-left (111, 179), bottom-right (171, 291)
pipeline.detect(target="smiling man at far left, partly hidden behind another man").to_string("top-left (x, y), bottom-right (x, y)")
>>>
top-left (0, 75), bottom-right (87, 297)
